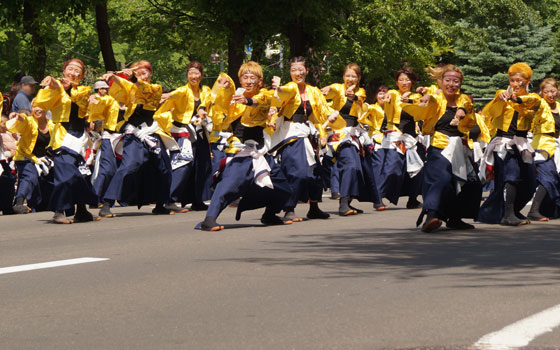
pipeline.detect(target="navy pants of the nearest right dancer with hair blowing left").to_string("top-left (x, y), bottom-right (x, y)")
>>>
top-left (422, 147), bottom-right (482, 220)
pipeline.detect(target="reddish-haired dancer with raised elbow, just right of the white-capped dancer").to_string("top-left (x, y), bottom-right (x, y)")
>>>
top-left (99, 61), bottom-right (178, 217)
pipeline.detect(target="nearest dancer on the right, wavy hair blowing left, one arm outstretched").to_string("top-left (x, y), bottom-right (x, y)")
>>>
top-left (403, 64), bottom-right (482, 233)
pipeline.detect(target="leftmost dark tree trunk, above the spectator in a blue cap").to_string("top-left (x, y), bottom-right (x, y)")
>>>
top-left (23, 0), bottom-right (47, 80)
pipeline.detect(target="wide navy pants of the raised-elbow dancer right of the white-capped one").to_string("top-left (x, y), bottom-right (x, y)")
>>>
top-left (104, 134), bottom-right (171, 207)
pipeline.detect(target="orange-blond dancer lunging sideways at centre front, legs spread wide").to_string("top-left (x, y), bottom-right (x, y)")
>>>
top-left (200, 61), bottom-right (292, 231)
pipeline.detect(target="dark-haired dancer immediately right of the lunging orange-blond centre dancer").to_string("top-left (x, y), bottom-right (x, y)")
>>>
top-left (269, 56), bottom-right (338, 222)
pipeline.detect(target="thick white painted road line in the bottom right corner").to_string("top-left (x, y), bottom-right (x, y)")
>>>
top-left (473, 304), bottom-right (560, 350)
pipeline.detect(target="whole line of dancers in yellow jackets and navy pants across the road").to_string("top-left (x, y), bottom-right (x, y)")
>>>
top-left (0, 57), bottom-right (560, 232)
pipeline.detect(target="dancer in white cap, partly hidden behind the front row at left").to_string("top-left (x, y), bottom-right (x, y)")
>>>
top-left (88, 80), bottom-right (121, 209)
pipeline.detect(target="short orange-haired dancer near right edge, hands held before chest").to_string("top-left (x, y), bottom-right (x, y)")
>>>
top-left (477, 62), bottom-right (550, 226)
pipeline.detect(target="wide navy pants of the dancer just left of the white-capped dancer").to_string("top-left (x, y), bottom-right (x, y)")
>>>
top-left (49, 147), bottom-right (98, 211)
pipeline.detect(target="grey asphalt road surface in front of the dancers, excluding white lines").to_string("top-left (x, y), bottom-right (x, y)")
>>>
top-left (0, 199), bottom-right (560, 349)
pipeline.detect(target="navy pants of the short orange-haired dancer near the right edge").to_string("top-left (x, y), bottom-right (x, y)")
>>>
top-left (477, 147), bottom-right (537, 224)
